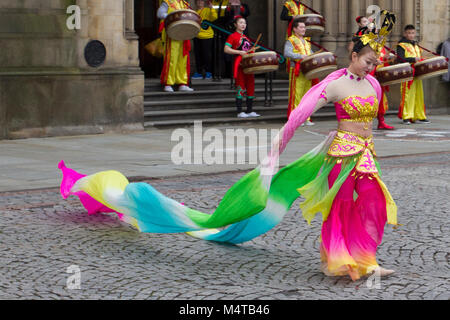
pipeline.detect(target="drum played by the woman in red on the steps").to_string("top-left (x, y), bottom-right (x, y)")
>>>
top-left (241, 51), bottom-right (278, 74)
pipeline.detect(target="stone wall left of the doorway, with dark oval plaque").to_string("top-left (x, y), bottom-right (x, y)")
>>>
top-left (0, 0), bottom-right (144, 139)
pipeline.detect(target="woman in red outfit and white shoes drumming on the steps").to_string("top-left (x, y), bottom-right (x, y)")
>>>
top-left (224, 16), bottom-right (260, 118)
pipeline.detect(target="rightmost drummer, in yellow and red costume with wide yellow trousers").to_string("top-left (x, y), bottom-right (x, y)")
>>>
top-left (397, 25), bottom-right (430, 125)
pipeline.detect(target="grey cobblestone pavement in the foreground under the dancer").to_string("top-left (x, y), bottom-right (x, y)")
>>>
top-left (0, 152), bottom-right (450, 300)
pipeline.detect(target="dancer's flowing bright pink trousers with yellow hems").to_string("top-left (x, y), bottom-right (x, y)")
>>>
top-left (321, 164), bottom-right (387, 279)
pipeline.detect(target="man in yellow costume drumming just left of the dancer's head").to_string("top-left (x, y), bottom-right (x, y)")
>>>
top-left (284, 18), bottom-right (318, 126)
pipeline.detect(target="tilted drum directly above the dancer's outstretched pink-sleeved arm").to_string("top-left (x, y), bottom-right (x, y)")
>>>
top-left (300, 52), bottom-right (337, 80)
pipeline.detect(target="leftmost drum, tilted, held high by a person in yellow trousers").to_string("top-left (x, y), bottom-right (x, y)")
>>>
top-left (164, 9), bottom-right (202, 40)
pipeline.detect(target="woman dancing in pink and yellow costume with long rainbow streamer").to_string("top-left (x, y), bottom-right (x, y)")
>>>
top-left (59, 13), bottom-right (397, 280)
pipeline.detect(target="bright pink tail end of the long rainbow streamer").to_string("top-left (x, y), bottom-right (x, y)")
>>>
top-left (58, 160), bottom-right (122, 218)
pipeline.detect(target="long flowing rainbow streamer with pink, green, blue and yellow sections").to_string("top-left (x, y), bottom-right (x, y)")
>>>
top-left (59, 69), bottom-right (381, 243)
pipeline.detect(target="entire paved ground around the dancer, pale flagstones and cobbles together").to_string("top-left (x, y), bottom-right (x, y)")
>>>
top-left (0, 116), bottom-right (450, 300)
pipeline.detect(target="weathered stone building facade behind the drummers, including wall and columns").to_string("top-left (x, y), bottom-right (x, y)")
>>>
top-left (0, 0), bottom-right (450, 139)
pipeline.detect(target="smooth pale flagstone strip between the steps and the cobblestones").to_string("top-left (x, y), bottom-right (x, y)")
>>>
top-left (0, 115), bottom-right (450, 192)
